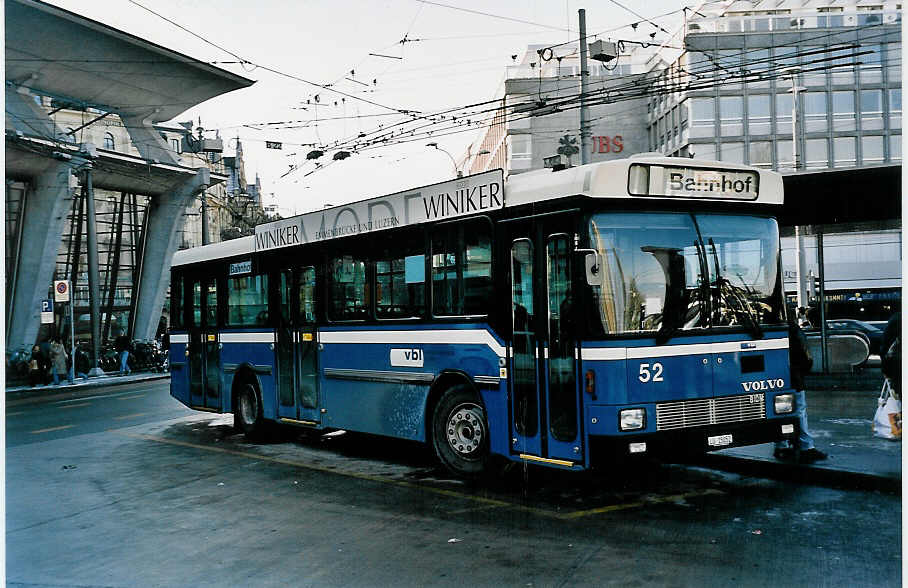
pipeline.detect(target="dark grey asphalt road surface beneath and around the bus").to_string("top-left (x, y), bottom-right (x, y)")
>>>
top-left (6, 381), bottom-right (901, 587)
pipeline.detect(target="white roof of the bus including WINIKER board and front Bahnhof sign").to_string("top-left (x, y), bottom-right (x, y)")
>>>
top-left (173, 155), bottom-right (783, 265)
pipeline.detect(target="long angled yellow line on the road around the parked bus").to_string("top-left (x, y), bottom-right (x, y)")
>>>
top-left (110, 430), bottom-right (725, 521)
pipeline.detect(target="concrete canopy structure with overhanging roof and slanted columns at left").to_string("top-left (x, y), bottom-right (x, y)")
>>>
top-left (4, 0), bottom-right (253, 362)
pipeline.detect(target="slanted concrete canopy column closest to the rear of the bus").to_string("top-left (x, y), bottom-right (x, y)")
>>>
top-left (131, 168), bottom-right (211, 339)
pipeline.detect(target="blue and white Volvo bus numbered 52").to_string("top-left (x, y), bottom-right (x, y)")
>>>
top-left (170, 157), bottom-right (797, 477)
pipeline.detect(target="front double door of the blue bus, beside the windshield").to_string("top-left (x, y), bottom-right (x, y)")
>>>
top-left (509, 219), bottom-right (583, 462)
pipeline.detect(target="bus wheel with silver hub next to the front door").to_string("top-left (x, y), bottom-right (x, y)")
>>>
top-left (432, 386), bottom-right (489, 478)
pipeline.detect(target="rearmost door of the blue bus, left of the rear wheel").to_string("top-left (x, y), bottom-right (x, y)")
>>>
top-left (187, 278), bottom-right (221, 410)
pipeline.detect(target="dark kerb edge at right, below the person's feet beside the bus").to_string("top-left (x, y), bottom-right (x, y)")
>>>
top-left (696, 454), bottom-right (902, 494)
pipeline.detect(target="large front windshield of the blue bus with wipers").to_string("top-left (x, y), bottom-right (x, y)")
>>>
top-left (590, 212), bottom-right (784, 341)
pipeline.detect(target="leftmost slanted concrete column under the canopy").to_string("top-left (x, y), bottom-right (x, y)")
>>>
top-left (6, 160), bottom-right (76, 349)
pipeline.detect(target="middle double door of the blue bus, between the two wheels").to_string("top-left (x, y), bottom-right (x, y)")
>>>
top-left (278, 266), bottom-right (320, 425)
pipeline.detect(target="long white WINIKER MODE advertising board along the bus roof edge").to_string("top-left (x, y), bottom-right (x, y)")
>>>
top-left (255, 169), bottom-right (504, 251)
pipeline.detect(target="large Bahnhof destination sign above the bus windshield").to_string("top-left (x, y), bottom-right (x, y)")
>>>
top-left (632, 165), bottom-right (759, 200)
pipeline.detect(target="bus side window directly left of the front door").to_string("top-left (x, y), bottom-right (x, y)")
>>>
top-left (432, 219), bottom-right (492, 316)
